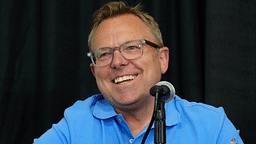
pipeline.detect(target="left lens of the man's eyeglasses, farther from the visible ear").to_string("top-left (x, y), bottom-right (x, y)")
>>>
top-left (93, 48), bottom-right (112, 66)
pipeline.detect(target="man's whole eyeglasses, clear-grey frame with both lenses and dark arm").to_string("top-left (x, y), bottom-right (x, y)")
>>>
top-left (87, 40), bottom-right (160, 67)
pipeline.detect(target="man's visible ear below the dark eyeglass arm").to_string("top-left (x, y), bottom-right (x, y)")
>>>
top-left (159, 47), bottom-right (169, 74)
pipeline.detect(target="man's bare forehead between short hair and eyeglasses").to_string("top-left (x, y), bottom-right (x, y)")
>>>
top-left (92, 14), bottom-right (154, 50)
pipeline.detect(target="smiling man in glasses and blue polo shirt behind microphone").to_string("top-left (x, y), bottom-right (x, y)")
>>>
top-left (34, 2), bottom-right (243, 144)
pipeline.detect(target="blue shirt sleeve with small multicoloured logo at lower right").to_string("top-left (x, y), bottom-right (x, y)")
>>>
top-left (217, 114), bottom-right (244, 144)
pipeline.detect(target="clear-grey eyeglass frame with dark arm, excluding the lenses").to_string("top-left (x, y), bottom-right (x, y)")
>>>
top-left (87, 39), bottom-right (161, 67)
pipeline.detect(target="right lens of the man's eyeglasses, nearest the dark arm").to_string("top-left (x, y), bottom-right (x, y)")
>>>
top-left (120, 41), bottom-right (143, 59)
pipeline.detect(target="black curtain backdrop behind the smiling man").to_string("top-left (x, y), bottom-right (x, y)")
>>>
top-left (0, 0), bottom-right (256, 144)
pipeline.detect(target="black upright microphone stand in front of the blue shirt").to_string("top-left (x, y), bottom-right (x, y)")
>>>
top-left (154, 92), bottom-right (166, 144)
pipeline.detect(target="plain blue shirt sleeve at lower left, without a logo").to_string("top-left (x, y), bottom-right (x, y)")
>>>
top-left (33, 118), bottom-right (70, 144)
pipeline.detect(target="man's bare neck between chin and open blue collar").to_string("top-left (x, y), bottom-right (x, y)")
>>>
top-left (115, 97), bottom-right (155, 137)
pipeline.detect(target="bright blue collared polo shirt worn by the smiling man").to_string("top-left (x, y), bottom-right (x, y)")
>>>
top-left (34, 94), bottom-right (243, 144)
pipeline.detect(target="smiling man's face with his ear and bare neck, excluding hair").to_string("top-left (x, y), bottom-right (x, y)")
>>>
top-left (88, 13), bottom-right (169, 136)
